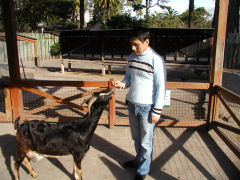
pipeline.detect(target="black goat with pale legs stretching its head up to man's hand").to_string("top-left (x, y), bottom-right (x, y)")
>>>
top-left (14, 88), bottom-right (113, 180)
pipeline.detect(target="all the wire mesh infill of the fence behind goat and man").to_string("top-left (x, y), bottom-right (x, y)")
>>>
top-left (0, 86), bottom-right (209, 125)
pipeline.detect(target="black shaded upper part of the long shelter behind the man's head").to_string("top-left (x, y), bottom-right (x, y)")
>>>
top-left (60, 28), bottom-right (213, 65)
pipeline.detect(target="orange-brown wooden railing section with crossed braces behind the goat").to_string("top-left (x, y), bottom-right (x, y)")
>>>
top-left (0, 80), bottom-right (115, 128)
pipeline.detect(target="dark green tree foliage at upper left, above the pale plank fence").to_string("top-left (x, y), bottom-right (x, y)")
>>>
top-left (16, 0), bottom-right (74, 32)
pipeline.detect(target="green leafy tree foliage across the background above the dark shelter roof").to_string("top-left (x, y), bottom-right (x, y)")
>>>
top-left (0, 0), bottom-right (214, 32)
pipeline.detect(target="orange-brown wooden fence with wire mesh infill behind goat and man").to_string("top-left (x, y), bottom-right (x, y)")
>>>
top-left (0, 80), bottom-right (210, 128)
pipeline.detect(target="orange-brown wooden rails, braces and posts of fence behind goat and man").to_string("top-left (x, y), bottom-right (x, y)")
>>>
top-left (0, 80), bottom-right (210, 128)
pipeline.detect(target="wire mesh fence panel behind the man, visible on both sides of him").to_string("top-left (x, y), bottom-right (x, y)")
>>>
top-left (115, 89), bottom-right (209, 124)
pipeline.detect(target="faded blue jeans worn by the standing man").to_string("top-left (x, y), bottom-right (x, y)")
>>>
top-left (128, 103), bottom-right (155, 175)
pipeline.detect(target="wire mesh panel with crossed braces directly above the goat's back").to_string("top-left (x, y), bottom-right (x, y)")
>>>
top-left (22, 86), bottom-right (109, 121)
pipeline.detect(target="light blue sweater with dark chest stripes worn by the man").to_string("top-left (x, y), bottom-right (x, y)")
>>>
top-left (123, 47), bottom-right (166, 117)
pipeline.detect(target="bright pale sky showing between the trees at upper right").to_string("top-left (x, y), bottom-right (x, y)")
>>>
top-left (153, 0), bottom-right (215, 13)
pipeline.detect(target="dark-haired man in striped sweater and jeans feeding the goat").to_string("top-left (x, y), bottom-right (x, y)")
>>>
top-left (113, 28), bottom-right (166, 180)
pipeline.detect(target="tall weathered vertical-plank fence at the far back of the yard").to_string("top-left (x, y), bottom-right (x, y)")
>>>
top-left (0, 33), bottom-right (240, 69)
